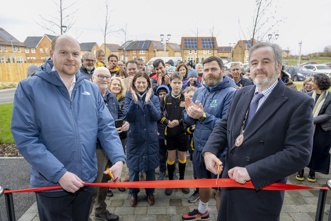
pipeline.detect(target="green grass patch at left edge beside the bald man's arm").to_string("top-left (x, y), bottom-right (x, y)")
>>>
top-left (0, 104), bottom-right (14, 143)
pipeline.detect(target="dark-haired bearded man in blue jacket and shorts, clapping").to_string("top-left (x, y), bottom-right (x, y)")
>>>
top-left (182, 56), bottom-right (236, 220)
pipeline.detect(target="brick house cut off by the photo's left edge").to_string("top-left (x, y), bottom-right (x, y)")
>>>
top-left (0, 28), bottom-right (26, 63)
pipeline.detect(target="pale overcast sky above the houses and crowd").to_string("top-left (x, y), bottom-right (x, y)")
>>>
top-left (0, 0), bottom-right (331, 54)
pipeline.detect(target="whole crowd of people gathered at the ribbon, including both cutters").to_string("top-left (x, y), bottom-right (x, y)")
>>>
top-left (11, 35), bottom-right (331, 221)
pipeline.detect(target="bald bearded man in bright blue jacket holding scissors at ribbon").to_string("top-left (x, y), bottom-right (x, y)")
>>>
top-left (11, 35), bottom-right (125, 220)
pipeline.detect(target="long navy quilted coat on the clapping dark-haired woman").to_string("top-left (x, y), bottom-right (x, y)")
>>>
top-left (124, 92), bottom-right (161, 172)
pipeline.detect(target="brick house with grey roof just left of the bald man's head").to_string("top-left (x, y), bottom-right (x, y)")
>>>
top-left (24, 34), bottom-right (56, 63)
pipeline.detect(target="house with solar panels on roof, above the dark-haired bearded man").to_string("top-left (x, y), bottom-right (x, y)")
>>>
top-left (180, 37), bottom-right (218, 63)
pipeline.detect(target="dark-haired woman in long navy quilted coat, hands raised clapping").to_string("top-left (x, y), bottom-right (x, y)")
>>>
top-left (124, 72), bottom-right (161, 207)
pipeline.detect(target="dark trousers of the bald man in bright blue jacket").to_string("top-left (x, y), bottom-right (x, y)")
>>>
top-left (36, 187), bottom-right (93, 221)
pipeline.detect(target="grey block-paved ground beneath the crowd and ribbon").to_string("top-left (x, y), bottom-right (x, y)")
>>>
top-left (15, 161), bottom-right (331, 221)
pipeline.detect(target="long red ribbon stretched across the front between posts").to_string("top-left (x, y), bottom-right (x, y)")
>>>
top-left (4, 178), bottom-right (329, 194)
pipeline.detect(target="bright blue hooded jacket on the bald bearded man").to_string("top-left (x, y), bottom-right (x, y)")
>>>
top-left (11, 60), bottom-right (125, 187)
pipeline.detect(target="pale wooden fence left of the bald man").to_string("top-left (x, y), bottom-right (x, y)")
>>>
top-left (0, 63), bottom-right (41, 83)
